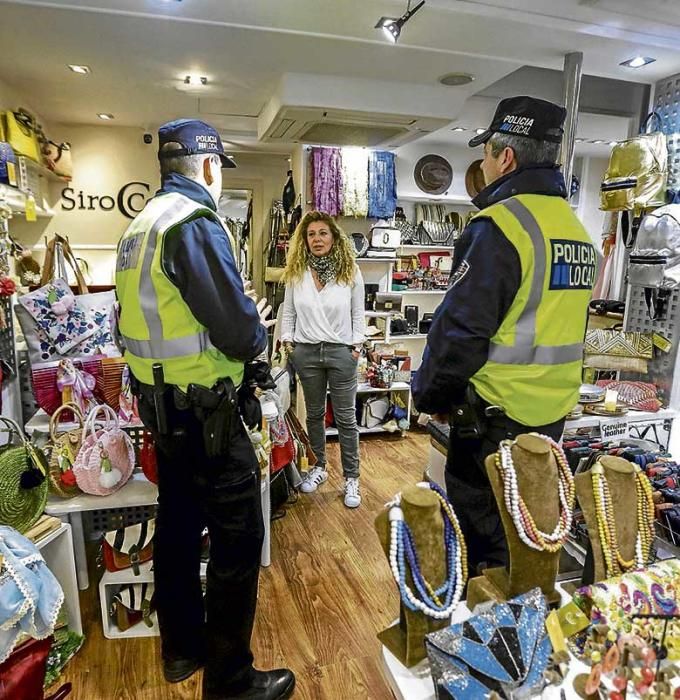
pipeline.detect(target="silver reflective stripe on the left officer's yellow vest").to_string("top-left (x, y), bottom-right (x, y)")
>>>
top-left (121, 197), bottom-right (214, 360)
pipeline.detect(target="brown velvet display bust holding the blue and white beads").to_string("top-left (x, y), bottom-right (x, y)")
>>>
top-left (375, 486), bottom-right (450, 667)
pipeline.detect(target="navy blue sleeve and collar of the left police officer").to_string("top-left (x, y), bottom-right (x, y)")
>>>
top-left (157, 173), bottom-right (267, 362)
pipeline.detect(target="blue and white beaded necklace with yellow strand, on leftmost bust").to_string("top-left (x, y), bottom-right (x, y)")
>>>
top-left (387, 482), bottom-right (467, 620)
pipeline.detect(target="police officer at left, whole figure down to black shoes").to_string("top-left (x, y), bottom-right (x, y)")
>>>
top-left (116, 119), bottom-right (295, 700)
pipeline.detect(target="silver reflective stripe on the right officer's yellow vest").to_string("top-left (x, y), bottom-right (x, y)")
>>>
top-left (489, 194), bottom-right (583, 365)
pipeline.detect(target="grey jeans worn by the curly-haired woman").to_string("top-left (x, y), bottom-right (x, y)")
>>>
top-left (290, 343), bottom-right (359, 478)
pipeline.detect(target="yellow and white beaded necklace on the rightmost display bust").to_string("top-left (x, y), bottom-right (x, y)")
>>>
top-left (591, 462), bottom-right (654, 578)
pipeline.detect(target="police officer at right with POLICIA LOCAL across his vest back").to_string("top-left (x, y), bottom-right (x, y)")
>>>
top-left (413, 97), bottom-right (595, 572)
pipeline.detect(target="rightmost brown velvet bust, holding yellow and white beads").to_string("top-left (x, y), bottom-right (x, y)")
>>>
top-left (574, 456), bottom-right (638, 584)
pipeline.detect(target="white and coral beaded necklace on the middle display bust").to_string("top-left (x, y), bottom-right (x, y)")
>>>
top-left (495, 433), bottom-right (576, 553)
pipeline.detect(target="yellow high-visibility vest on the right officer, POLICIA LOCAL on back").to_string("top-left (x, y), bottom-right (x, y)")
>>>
top-left (470, 194), bottom-right (597, 426)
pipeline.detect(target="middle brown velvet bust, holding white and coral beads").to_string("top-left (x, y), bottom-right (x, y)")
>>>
top-left (467, 435), bottom-right (560, 610)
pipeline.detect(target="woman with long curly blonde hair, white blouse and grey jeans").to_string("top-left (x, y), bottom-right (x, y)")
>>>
top-left (281, 211), bottom-right (366, 508)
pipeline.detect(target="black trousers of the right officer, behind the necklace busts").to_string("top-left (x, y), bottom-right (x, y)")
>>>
top-left (446, 408), bottom-right (564, 577)
